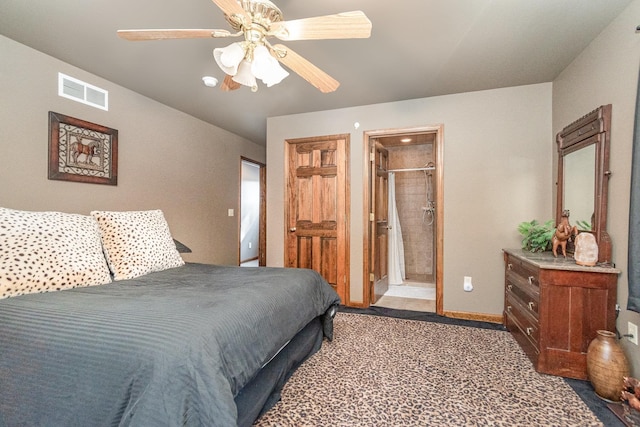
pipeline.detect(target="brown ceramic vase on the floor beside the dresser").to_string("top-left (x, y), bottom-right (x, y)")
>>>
top-left (587, 330), bottom-right (629, 402)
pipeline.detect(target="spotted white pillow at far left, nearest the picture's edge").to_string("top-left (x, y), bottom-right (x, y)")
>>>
top-left (0, 208), bottom-right (111, 299)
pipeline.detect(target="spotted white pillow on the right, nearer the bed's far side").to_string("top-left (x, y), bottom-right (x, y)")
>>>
top-left (91, 210), bottom-right (184, 280)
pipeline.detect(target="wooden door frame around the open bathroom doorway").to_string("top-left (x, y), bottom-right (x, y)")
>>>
top-left (362, 124), bottom-right (444, 315)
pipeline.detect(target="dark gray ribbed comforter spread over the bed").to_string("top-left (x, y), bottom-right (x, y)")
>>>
top-left (0, 264), bottom-right (339, 427)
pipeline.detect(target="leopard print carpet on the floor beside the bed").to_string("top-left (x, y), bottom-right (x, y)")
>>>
top-left (255, 313), bottom-right (603, 427)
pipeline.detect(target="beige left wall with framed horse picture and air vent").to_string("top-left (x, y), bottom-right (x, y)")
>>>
top-left (0, 36), bottom-right (265, 264)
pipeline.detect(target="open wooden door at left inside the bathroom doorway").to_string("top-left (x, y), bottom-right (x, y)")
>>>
top-left (369, 140), bottom-right (389, 304)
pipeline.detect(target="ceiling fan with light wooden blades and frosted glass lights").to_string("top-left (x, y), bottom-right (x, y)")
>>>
top-left (118, 0), bottom-right (371, 93)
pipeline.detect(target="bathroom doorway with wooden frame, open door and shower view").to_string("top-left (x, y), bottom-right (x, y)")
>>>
top-left (364, 125), bottom-right (444, 314)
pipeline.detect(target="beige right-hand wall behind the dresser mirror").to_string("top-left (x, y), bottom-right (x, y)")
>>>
top-left (553, 0), bottom-right (640, 376)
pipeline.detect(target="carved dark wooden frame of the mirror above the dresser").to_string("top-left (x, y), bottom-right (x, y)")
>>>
top-left (556, 104), bottom-right (611, 264)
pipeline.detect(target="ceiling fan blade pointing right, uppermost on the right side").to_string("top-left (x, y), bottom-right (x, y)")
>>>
top-left (270, 10), bottom-right (371, 40)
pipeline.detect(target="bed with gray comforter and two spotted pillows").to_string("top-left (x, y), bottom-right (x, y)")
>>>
top-left (0, 208), bottom-right (339, 426)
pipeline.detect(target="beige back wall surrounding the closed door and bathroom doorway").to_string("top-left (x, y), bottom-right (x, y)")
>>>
top-left (267, 83), bottom-right (553, 315)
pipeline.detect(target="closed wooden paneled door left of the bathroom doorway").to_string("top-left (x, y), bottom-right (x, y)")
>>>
top-left (285, 135), bottom-right (349, 304)
